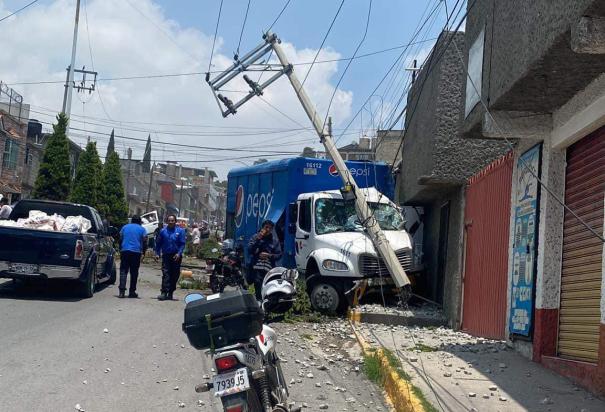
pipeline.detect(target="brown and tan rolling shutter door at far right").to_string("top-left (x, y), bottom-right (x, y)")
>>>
top-left (558, 128), bottom-right (605, 363)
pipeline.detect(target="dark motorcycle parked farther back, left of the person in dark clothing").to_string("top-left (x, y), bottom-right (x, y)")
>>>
top-left (206, 241), bottom-right (246, 293)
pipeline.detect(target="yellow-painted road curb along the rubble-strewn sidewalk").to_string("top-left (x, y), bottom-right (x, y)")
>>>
top-left (347, 311), bottom-right (425, 412)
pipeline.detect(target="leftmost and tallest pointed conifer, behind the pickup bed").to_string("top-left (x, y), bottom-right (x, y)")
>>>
top-left (32, 113), bottom-right (71, 201)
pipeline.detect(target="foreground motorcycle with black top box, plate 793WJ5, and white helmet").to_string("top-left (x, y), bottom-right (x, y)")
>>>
top-left (183, 268), bottom-right (301, 412)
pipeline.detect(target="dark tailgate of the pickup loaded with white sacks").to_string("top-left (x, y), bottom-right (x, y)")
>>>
top-left (0, 227), bottom-right (82, 267)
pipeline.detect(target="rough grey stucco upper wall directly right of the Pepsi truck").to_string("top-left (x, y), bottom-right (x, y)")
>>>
top-left (399, 32), bottom-right (508, 202)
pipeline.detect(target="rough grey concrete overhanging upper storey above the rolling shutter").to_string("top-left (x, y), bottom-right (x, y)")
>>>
top-left (464, 0), bottom-right (605, 137)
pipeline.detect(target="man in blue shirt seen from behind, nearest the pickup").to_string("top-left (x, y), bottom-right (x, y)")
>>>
top-left (119, 215), bottom-right (147, 298)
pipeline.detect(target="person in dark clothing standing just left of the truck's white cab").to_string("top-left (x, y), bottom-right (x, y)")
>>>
top-left (248, 220), bottom-right (282, 301)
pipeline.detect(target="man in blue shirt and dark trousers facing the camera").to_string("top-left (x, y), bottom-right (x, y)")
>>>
top-left (155, 215), bottom-right (185, 300)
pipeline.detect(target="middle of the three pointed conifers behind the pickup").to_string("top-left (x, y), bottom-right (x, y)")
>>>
top-left (69, 142), bottom-right (103, 210)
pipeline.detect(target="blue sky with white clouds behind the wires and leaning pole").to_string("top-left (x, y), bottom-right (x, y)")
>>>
top-left (0, 0), bottom-right (452, 177)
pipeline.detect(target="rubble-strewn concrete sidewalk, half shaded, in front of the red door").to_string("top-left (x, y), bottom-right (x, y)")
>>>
top-left (355, 323), bottom-right (605, 412)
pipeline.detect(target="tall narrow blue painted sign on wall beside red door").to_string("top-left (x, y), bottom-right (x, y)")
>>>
top-left (509, 144), bottom-right (542, 336)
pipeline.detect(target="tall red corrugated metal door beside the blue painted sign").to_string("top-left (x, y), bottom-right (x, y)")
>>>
top-left (462, 152), bottom-right (513, 339)
